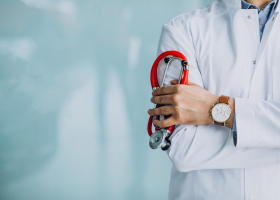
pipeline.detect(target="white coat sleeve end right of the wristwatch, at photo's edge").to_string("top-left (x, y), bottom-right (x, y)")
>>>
top-left (235, 98), bottom-right (280, 148)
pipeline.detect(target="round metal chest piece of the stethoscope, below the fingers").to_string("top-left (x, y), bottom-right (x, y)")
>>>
top-left (149, 130), bottom-right (171, 151)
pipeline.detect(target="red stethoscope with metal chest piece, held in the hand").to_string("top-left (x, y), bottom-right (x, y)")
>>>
top-left (147, 51), bottom-right (189, 151)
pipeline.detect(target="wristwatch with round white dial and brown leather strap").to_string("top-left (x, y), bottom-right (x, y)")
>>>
top-left (210, 95), bottom-right (231, 126)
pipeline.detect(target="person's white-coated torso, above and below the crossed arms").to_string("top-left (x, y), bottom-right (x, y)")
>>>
top-left (169, 0), bottom-right (280, 200)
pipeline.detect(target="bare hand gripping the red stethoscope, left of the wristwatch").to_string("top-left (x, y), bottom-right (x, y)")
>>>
top-left (148, 80), bottom-right (219, 127)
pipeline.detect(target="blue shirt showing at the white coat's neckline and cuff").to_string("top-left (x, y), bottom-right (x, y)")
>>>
top-left (232, 0), bottom-right (278, 146)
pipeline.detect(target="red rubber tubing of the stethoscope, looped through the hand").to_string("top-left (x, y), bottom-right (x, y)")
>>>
top-left (147, 51), bottom-right (189, 139)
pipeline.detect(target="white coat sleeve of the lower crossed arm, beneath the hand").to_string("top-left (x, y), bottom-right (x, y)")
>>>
top-left (168, 124), bottom-right (280, 172)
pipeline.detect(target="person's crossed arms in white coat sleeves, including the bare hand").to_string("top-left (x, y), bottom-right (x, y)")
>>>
top-left (148, 24), bottom-right (280, 172)
